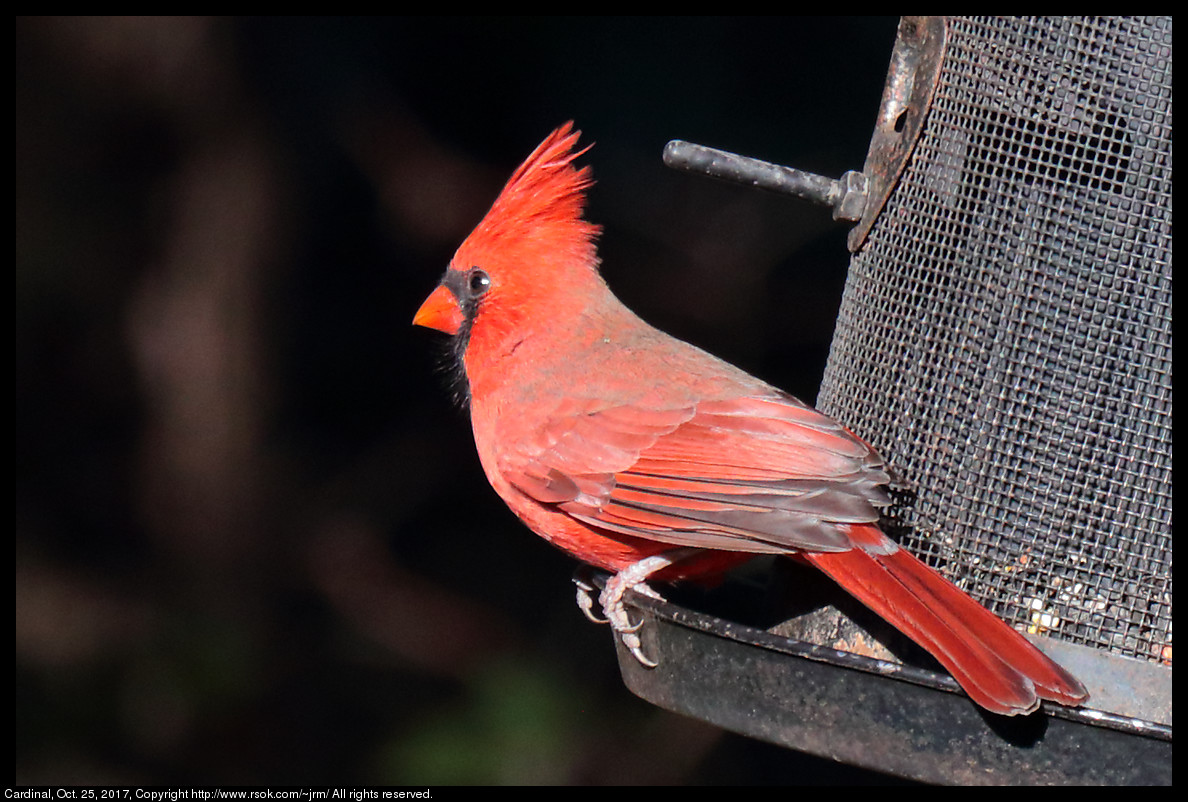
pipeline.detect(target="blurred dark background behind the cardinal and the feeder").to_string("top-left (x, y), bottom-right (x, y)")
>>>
top-left (15, 17), bottom-right (896, 784)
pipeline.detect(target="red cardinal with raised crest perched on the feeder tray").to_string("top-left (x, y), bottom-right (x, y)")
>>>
top-left (413, 124), bottom-right (1088, 715)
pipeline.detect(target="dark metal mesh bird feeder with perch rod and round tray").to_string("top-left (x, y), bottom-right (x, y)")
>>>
top-left (581, 17), bottom-right (1171, 784)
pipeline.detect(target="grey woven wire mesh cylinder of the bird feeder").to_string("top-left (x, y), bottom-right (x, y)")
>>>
top-left (817, 17), bottom-right (1171, 663)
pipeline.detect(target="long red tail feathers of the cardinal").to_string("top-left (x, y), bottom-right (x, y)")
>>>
top-left (802, 526), bottom-right (1088, 715)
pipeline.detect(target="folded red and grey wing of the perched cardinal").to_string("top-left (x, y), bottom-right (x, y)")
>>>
top-left (499, 393), bottom-right (890, 552)
